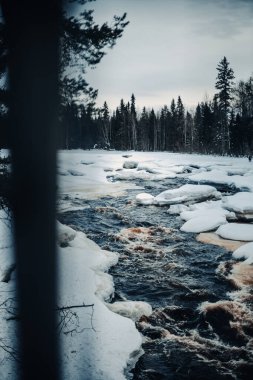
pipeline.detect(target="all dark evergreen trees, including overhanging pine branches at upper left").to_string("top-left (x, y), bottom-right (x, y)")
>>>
top-left (0, 0), bottom-right (253, 155)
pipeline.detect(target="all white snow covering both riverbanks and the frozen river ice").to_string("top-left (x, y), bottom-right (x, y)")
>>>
top-left (0, 150), bottom-right (253, 380)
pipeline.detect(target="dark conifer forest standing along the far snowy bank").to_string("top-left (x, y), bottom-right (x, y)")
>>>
top-left (58, 57), bottom-right (253, 156)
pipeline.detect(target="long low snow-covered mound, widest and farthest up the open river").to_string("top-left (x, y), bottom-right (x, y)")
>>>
top-left (154, 185), bottom-right (221, 206)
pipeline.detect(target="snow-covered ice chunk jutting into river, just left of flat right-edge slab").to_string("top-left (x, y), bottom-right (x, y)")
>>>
top-left (180, 212), bottom-right (227, 233)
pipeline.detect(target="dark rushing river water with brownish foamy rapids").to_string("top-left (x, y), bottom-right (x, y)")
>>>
top-left (59, 178), bottom-right (253, 380)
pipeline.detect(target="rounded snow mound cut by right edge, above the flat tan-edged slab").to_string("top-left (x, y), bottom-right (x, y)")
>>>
top-left (223, 192), bottom-right (253, 213)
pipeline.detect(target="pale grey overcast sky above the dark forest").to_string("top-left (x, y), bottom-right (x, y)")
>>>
top-left (86, 0), bottom-right (253, 109)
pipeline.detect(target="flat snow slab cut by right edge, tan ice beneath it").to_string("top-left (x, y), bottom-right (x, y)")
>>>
top-left (216, 223), bottom-right (253, 241)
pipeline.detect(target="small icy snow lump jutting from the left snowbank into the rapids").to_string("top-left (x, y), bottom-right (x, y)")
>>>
top-left (107, 301), bottom-right (152, 321)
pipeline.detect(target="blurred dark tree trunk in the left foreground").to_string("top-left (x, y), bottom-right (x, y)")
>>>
top-left (2, 0), bottom-right (60, 380)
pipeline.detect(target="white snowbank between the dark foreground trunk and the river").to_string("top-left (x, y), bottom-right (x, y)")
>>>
top-left (59, 227), bottom-right (142, 380)
